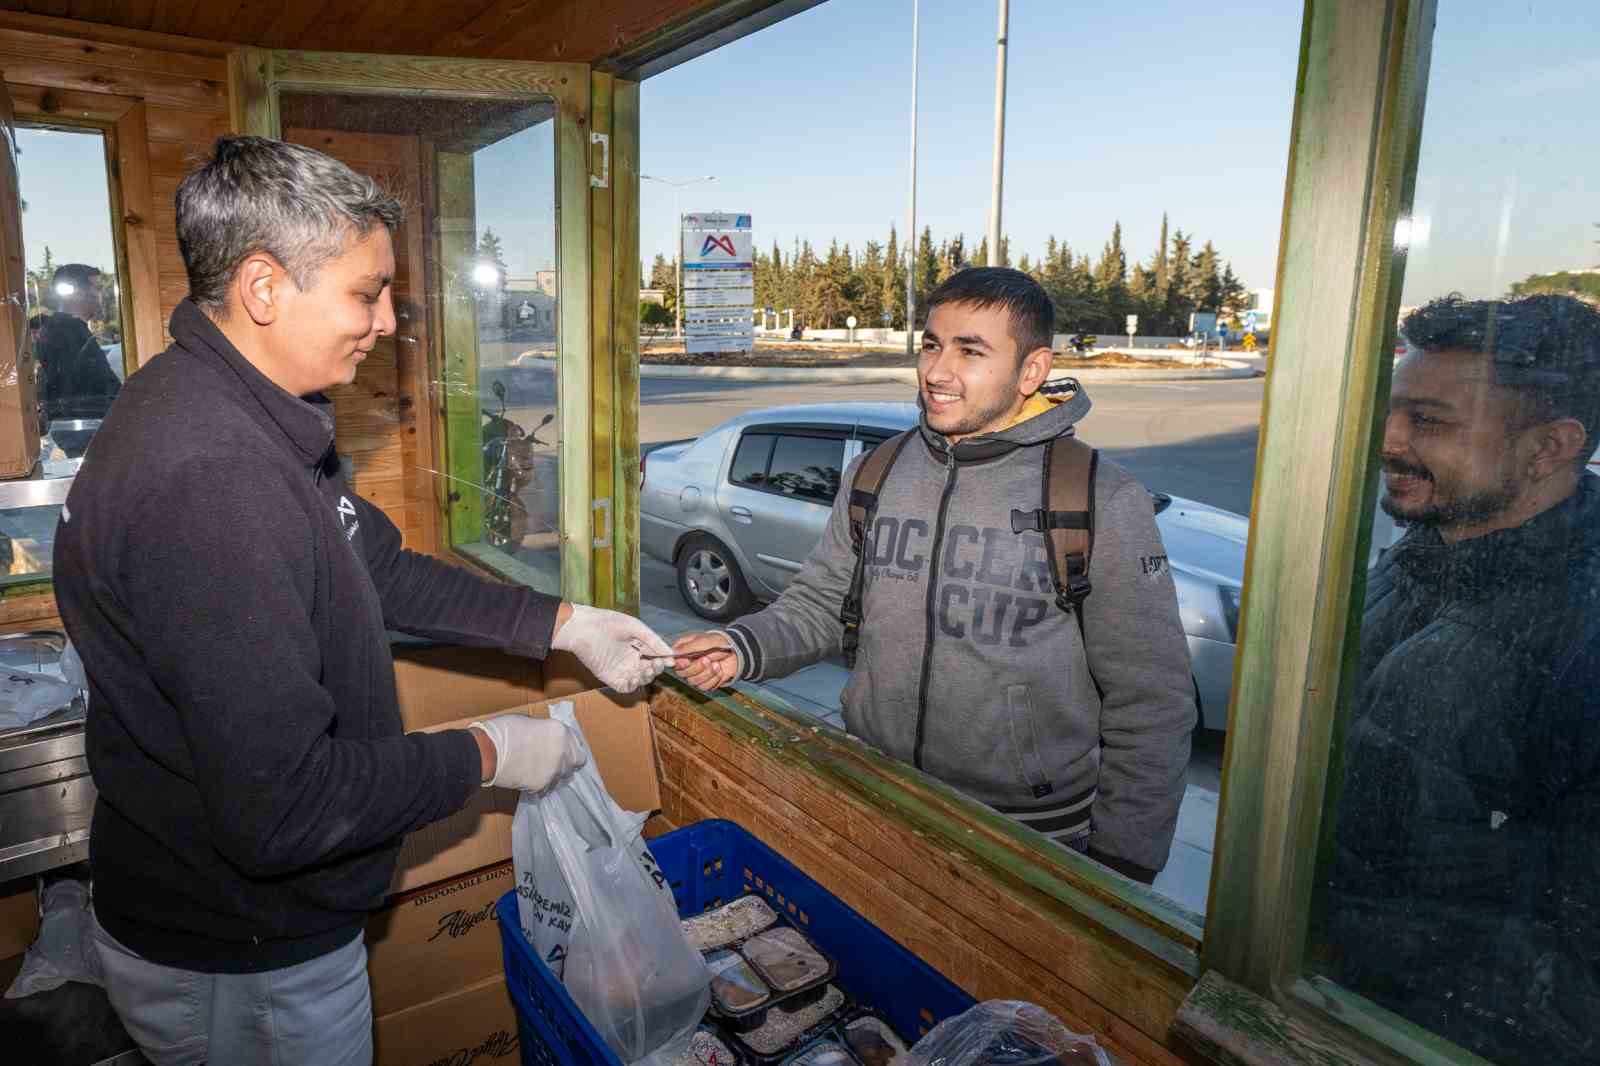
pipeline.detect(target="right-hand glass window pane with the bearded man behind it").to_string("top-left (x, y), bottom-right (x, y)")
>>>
top-left (1307, 0), bottom-right (1600, 1063)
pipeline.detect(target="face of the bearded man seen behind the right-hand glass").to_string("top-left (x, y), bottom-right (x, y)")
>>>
top-left (1379, 351), bottom-right (1531, 539)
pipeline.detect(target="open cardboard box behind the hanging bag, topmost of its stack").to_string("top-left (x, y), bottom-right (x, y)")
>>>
top-left (390, 688), bottom-right (661, 893)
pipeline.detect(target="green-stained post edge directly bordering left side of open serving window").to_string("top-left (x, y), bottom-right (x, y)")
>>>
top-left (611, 80), bottom-right (640, 613)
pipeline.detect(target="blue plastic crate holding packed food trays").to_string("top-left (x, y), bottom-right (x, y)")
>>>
top-left (498, 820), bottom-right (973, 1066)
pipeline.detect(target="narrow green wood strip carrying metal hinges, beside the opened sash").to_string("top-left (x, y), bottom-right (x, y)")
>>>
top-left (589, 72), bottom-right (618, 608)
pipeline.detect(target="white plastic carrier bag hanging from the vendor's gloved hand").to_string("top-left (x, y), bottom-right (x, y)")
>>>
top-left (512, 701), bottom-right (710, 1066)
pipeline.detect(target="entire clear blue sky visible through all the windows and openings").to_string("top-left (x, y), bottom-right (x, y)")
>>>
top-left (12, 0), bottom-right (1600, 303)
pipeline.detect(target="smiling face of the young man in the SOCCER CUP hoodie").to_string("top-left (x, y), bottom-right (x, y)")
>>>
top-left (917, 304), bottom-right (1050, 443)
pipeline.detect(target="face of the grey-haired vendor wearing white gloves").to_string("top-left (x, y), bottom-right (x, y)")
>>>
top-left (272, 226), bottom-right (395, 395)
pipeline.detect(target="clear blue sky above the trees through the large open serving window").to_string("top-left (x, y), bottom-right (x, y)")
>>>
top-left (640, 0), bottom-right (1299, 287)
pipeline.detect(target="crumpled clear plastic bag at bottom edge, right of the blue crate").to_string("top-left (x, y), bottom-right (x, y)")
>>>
top-left (906, 999), bottom-right (1112, 1066)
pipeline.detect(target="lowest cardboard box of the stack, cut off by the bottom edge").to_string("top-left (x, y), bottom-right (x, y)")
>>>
top-left (373, 976), bottom-right (520, 1066)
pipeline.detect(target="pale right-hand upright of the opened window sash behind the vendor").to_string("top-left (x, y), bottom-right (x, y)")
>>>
top-left (555, 76), bottom-right (594, 603)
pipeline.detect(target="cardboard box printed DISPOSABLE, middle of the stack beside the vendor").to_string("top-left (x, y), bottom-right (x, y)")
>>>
top-left (366, 863), bottom-right (514, 1018)
